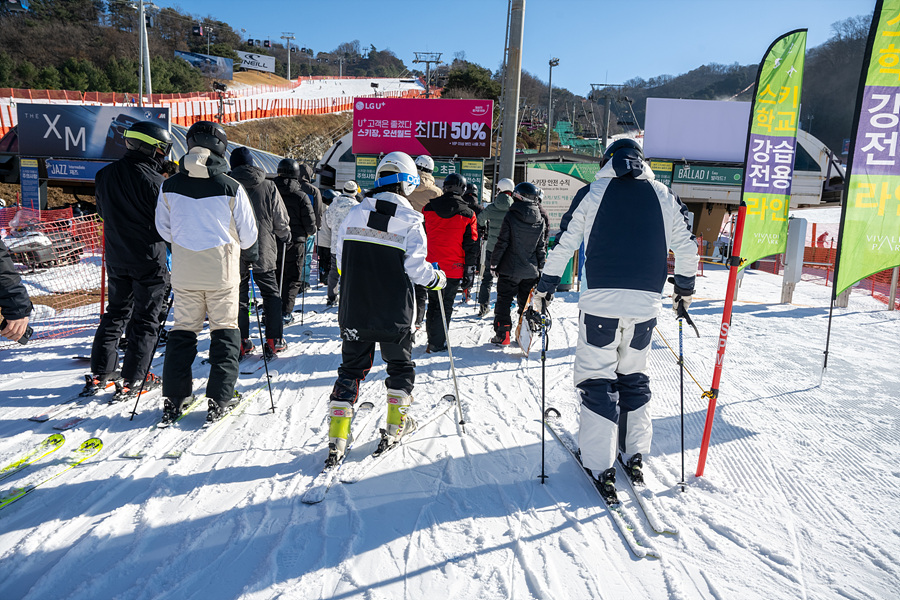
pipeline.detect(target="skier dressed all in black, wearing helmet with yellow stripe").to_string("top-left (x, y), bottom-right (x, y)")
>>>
top-left (88, 121), bottom-right (172, 400)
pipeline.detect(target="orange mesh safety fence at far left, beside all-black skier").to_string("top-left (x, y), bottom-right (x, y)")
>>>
top-left (0, 209), bottom-right (103, 348)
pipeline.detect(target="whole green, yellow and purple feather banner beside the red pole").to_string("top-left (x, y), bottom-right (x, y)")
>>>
top-left (741, 29), bottom-right (806, 266)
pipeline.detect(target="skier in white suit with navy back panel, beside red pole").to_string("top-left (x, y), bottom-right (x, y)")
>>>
top-left (534, 140), bottom-right (698, 495)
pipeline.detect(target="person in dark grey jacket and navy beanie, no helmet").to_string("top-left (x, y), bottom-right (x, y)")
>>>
top-left (230, 147), bottom-right (291, 358)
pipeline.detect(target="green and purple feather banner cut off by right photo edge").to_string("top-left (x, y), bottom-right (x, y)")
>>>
top-left (834, 0), bottom-right (900, 294)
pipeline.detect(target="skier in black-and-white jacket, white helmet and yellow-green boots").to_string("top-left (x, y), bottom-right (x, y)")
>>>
top-left (326, 152), bottom-right (447, 466)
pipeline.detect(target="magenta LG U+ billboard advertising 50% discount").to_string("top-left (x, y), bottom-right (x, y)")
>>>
top-left (353, 98), bottom-right (494, 157)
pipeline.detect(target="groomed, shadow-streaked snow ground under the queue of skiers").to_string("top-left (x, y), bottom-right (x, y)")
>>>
top-left (0, 265), bottom-right (900, 600)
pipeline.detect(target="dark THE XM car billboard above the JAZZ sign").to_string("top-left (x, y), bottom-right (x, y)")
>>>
top-left (17, 103), bottom-right (169, 160)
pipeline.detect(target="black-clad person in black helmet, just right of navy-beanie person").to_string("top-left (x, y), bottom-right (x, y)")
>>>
top-left (275, 158), bottom-right (316, 325)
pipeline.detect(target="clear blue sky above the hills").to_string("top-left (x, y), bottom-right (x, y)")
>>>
top-left (155, 0), bottom-right (875, 95)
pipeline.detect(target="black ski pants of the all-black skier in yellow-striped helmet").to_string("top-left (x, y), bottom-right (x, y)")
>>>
top-left (91, 263), bottom-right (169, 381)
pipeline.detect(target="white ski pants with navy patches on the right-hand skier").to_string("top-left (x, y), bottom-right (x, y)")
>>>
top-left (575, 312), bottom-right (656, 475)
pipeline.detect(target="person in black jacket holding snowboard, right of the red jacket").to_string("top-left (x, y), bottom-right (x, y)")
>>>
top-left (491, 181), bottom-right (547, 346)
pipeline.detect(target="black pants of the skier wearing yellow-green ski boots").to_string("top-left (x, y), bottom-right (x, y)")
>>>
top-left (338, 334), bottom-right (416, 394)
